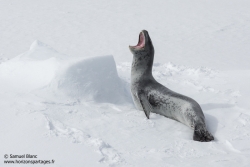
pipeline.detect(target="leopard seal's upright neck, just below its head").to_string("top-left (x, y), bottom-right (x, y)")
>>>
top-left (131, 54), bottom-right (154, 81)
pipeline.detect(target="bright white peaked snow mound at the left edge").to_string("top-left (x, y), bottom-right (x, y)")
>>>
top-left (0, 41), bottom-right (61, 93)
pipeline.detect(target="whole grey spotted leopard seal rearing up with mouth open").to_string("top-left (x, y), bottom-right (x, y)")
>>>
top-left (129, 30), bottom-right (214, 142)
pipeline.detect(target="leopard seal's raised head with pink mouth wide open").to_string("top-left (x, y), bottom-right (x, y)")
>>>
top-left (129, 30), bottom-right (154, 57)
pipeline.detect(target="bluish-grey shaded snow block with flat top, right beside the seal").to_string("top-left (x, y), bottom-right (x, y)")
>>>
top-left (52, 56), bottom-right (130, 103)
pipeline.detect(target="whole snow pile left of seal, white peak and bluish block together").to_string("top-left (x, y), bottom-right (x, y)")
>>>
top-left (0, 40), bottom-right (131, 103)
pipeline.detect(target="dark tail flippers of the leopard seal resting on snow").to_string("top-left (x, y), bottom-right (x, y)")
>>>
top-left (193, 125), bottom-right (214, 142)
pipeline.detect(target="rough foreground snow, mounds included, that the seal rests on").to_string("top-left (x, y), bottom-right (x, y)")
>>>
top-left (0, 41), bottom-right (250, 166)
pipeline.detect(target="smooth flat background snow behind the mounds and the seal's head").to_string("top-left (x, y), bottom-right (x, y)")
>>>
top-left (0, 0), bottom-right (250, 69)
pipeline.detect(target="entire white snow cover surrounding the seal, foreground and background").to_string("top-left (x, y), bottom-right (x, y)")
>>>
top-left (0, 0), bottom-right (250, 167)
